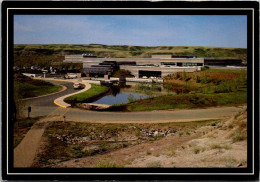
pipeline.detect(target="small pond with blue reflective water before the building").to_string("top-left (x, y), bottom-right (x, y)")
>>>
top-left (93, 92), bottom-right (148, 105)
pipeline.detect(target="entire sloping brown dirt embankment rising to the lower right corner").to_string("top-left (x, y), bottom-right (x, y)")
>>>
top-left (40, 107), bottom-right (247, 168)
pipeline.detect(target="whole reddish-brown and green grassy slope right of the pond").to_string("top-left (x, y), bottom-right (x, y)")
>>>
top-left (106, 70), bottom-right (247, 111)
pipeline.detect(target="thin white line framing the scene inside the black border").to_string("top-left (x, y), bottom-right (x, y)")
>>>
top-left (6, 8), bottom-right (255, 175)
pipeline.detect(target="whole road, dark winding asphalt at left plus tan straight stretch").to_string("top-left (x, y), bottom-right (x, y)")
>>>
top-left (20, 81), bottom-right (246, 123)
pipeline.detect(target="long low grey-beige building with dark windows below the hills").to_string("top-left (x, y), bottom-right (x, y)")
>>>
top-left (64, 54), bottom-right (242, 78)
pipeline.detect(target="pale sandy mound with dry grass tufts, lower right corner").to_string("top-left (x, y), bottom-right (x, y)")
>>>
top-left (127, 106), bottom-right (247, 168)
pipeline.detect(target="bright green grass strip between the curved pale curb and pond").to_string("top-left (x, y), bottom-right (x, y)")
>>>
top-left (64, 84), bottom-right (109, 102)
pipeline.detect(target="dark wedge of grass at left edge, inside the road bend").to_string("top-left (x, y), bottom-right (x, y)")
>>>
top-left (14, 75), bottom-right (62, 99)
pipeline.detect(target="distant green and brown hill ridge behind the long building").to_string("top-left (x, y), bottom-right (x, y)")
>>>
top-left (14, 44), bottom-right (247, 66)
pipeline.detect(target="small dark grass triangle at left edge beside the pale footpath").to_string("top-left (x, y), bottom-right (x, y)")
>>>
top-left (13, 118), bottom-right (39, 148)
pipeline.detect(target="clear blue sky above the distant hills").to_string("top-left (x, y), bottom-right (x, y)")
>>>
top-left (14, 15), bottom-right (247, 48)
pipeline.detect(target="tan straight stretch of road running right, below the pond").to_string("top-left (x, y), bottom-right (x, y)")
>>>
top-left (62, 106), bottom-right (243, 123)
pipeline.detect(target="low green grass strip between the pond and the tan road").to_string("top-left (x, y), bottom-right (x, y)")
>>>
top-left (117, 91), bottom-right (247, 111)
